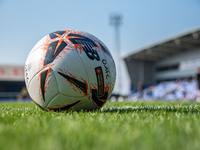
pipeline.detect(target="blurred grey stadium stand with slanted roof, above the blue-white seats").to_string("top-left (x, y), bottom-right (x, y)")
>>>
top-left (123, 28), bottom-right (200, 87)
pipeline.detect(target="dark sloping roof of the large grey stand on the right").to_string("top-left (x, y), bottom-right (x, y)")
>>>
top-left (123, 28), bottom-right (200, 61)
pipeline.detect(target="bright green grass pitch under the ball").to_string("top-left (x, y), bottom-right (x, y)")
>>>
top-left (0, 102), bottom-right (200, 150)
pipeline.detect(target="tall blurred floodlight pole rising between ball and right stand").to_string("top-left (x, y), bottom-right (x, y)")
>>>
top-left (110, 14), bottom-right (122, 95)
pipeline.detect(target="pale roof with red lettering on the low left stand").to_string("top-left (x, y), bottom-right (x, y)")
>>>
top-left (0, 66), bottom-right (24, 81)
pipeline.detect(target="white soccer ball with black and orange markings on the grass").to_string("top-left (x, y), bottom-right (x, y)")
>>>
top-left (25, 30), bottom-right (116, 111)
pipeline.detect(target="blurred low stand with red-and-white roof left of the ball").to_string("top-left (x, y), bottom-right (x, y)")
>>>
top-left (0, 65), bottom-right (25, 100)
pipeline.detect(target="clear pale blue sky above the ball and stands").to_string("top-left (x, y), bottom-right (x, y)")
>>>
top-left (0, 0), bottom-right (200, 94)
